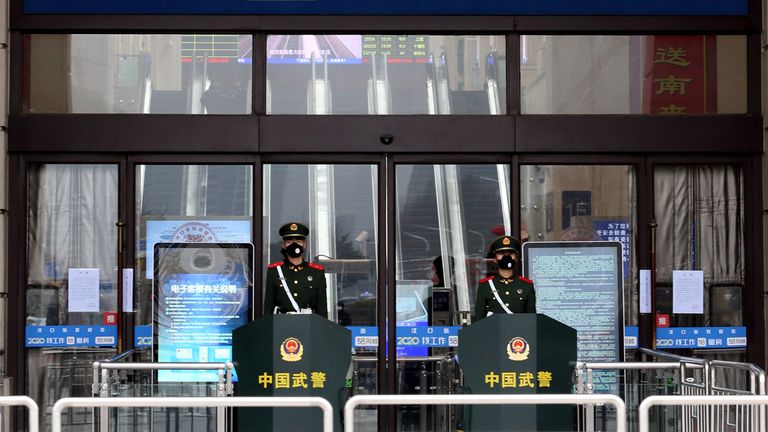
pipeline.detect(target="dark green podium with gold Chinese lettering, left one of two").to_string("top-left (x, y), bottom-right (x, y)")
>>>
top-left (232, 314), bottom-right (352, 432)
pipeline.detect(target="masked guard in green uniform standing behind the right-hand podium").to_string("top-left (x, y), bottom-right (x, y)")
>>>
top-left (475, 236), bottom-right (536, 321)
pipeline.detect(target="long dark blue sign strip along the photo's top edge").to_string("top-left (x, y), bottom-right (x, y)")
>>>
top-left (24, 0), bottom-right (748, 15)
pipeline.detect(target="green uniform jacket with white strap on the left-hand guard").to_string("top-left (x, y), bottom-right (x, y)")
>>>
top-left (264, 261), bottom-right (328, 318)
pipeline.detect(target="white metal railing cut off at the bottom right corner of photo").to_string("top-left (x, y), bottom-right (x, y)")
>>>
top-left (639, 395), bottom-right (768, 432)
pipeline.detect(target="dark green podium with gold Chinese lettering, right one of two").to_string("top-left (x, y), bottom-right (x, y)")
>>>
top-left (459, 314), bottom-right (576, 432)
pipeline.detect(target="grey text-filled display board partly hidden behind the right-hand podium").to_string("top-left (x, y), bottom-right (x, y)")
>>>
top-left (523, 241), bottom-right (624, 393)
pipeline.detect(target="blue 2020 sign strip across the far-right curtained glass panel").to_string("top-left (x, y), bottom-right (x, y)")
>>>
top-left (656, 327), bottom-right (747, 349)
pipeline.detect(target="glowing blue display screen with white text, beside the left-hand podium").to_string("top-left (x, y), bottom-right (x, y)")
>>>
top-left (153, 243), bottom-right (253, 382)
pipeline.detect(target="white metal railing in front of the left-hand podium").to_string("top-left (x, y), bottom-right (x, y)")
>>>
top-left (51, 396), bottom-right (333, 432)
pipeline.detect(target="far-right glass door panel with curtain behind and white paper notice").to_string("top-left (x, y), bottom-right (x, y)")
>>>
top-left (654, 165), bottom-right (746, 327)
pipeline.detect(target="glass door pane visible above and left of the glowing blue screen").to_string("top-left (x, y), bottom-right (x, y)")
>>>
top-left (134, 165), bottom-right (253, 325)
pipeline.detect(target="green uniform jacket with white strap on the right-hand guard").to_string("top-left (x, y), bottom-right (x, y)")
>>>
top-left (475, 276), bottom-right (536, 321)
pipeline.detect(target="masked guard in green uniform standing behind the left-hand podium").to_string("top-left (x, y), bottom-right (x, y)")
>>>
top-left (264, 222), bottom-right (328, 318)
